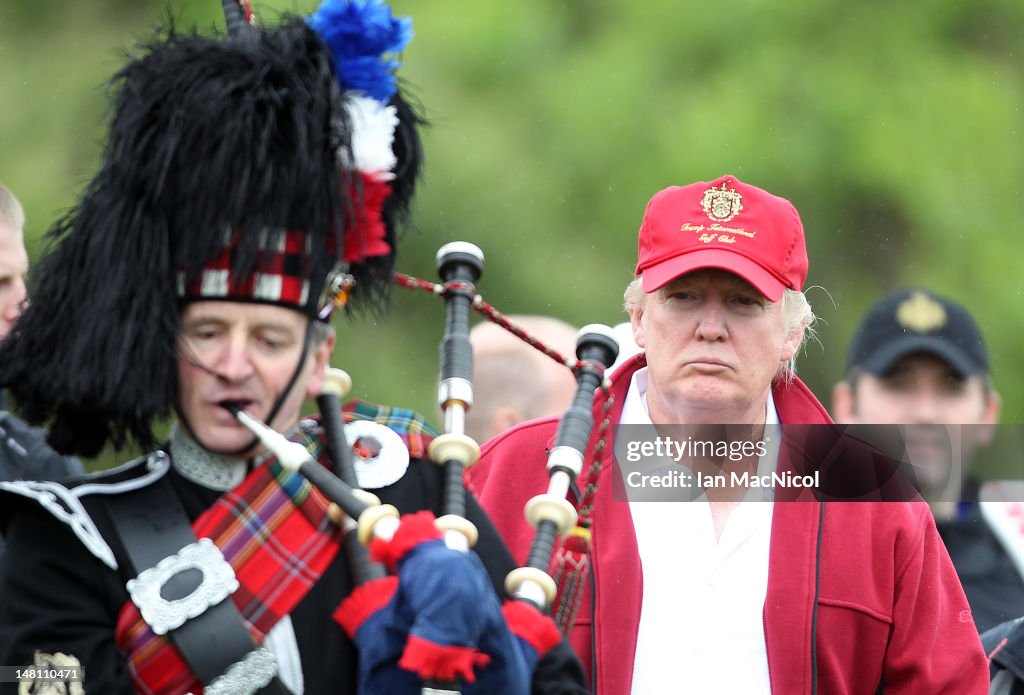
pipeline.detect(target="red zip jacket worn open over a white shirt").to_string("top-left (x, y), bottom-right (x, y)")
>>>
top-left (467, 355), bottom-right (988, 695)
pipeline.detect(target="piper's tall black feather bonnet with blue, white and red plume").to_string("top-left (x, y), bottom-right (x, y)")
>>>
top-left (0, 0), bottom-right (422, 457)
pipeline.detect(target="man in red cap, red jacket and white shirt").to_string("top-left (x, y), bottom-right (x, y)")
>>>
top-left (470, 176), bottom-right (987, 695)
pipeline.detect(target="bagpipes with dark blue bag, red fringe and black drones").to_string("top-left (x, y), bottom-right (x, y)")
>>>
top-left (236, 243), bottom-right (617, 693)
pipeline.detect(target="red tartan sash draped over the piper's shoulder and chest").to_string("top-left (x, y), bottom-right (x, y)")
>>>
top-left (116, 401), bottom-right (436, 695)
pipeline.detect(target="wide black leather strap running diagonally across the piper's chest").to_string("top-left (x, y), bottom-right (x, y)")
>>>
top-left (106, 475), bottom-right (288, 695)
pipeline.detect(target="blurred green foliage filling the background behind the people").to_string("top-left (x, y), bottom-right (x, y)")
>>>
top-left (0, 0), bottom-right (1024, 465)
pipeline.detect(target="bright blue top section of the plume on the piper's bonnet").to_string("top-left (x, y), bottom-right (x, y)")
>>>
top-left (308, 0), bottom-right (413, 103)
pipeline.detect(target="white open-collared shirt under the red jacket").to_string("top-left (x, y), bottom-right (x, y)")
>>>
top-left (615, 367), bottom-right (778, 695)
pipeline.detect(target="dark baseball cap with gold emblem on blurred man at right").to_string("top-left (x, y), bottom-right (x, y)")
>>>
top-left (847, 288), bottom-right (988, 377)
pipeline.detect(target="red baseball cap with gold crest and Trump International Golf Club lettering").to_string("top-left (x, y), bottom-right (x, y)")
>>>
top-left (636, 176), bottom-right (807, 302)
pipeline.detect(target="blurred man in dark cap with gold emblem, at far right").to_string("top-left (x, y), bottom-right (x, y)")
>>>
top-left (833, 288), bottom-right (1024, 631)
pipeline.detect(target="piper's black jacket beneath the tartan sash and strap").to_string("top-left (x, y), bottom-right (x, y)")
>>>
top-left (0, 423), bottom-right (588, 695)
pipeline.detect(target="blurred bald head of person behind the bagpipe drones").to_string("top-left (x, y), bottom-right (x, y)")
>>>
top-left (466, 315), bottom-right (577, 443)
